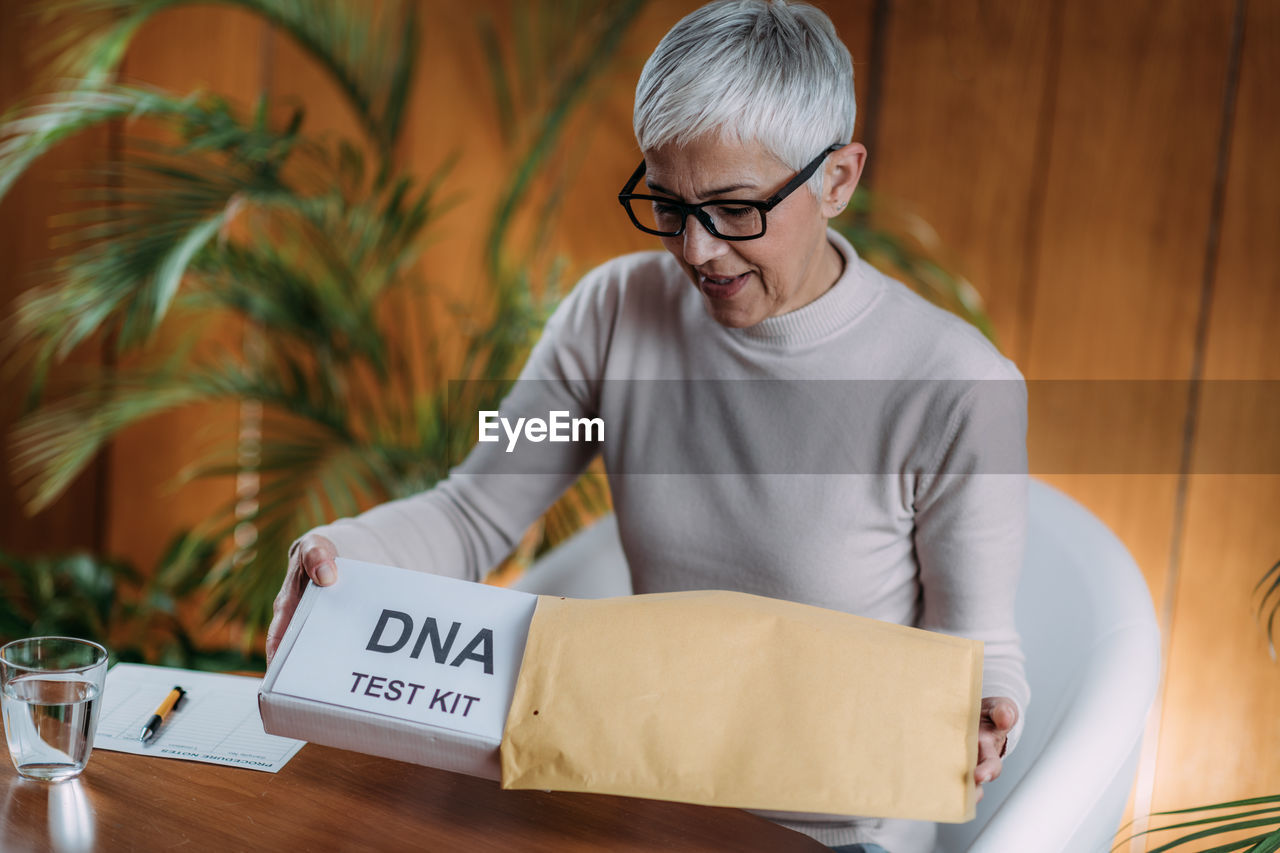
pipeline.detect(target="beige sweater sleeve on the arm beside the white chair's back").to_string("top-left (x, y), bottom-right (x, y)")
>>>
top-left (915, 362), bottom-right (1030, 754)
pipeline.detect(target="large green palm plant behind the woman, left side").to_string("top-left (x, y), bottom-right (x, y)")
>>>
top-left (0, 0), bottom-right (641, 633)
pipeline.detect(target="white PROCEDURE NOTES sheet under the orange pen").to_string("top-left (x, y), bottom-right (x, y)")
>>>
top-left (93, 663), bottom-right (306, 774)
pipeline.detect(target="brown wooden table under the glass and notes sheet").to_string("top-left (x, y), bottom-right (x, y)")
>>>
top-left (0, 712), bottom-right (827, 853)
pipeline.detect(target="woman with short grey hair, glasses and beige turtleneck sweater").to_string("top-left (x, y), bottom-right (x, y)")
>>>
top-left (268, 0), bottom-right (1029, 853)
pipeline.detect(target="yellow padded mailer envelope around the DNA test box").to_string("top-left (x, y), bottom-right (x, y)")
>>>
top-left (502, 590), bottom-right (982, 822)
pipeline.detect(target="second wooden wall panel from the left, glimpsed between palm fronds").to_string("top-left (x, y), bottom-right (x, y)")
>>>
top-left (106, 6), bottom-right (265, 571)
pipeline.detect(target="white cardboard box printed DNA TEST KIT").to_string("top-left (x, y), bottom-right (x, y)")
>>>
top-left (257, 557), bottom-right (538, 779)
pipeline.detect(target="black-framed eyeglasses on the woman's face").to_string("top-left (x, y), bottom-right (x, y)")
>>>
top-left (618, 142), bottom-right (845, 240)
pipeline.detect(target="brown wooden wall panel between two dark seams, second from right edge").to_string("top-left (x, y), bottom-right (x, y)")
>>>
top-left (1023, 0), bottom-right (1231, 655)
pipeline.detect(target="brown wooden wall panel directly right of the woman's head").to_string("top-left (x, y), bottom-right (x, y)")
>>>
top-left (869, 0), bottom-right (1055, 360)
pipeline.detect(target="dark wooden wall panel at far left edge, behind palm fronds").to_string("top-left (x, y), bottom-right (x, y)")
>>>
top-left (0, 0), bottom-right (111, 553)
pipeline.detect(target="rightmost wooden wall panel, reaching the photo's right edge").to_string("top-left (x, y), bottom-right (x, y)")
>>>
top-left (1153, 0), bottom-right (1280, 829)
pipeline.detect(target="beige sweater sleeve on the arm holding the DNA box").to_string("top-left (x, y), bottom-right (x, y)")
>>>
top-left (302, 268), bottom-right (608, 580)
